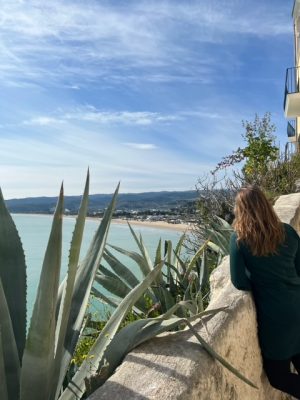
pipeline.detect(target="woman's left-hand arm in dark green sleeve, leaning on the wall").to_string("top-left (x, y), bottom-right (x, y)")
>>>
top-left (230, 233), bottom-right (251, 290)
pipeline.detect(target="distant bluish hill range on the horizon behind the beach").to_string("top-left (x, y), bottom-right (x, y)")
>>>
top-left (6, 190), bottom-right (197, 213)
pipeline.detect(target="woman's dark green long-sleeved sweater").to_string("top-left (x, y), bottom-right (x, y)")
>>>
top-left (230, 224), bottom-right (300, 360)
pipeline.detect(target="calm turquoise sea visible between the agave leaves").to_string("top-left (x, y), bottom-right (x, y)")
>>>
top-left (12, 214), bottom-right (182, 318)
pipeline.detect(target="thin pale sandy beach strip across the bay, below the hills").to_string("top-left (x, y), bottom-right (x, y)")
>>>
top-left (12, 213), bottom-right (192, 233)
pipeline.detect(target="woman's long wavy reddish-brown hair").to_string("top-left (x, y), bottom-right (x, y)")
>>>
top-left (233, 186), bottom-right (285, 256)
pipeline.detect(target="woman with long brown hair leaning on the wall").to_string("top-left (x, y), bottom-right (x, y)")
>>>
top-left (230, 186), bottom-right (300, 399)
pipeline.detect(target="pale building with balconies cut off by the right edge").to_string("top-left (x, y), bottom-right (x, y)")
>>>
top-left (284, 0), bottom-right (300, 150)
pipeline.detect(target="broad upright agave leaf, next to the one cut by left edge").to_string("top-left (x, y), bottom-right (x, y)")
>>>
top-left (20, 187), bottom-right (63, 400)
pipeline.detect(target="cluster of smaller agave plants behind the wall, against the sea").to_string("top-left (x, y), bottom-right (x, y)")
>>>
top-left (93, 224), bottom-right (208, 316)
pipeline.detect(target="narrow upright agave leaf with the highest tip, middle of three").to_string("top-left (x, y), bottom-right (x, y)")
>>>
top-left (51, 171), bottom-right (90, 398)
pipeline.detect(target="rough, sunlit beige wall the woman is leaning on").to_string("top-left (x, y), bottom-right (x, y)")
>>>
top-left (89, 193), bottom-right (300, 400)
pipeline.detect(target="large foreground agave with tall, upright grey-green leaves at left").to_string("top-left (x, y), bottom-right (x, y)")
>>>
top-left (0, 175), bottom-right (161, 400)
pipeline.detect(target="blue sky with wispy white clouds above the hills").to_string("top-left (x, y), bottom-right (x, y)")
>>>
top-left (0, 0), bottom-right (294, 199)
